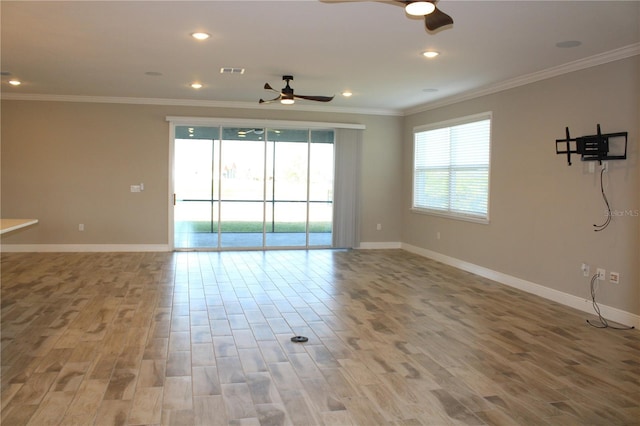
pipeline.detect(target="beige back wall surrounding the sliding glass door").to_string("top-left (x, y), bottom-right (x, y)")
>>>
top-left (0, 100), bottom-right (402, 247)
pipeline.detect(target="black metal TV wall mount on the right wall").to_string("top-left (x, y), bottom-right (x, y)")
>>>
top-left (556, 124), bottom-right (627, 165)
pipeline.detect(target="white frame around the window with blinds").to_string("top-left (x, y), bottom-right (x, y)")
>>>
top-left (410, 111), bottom-right (493, 224)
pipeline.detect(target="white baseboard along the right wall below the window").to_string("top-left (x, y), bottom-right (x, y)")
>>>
top-left (402, 243), bottom-right (640, 328)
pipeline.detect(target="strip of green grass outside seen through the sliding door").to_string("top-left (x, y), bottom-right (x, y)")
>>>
top-left (177, 221), bottom-right (331, 233)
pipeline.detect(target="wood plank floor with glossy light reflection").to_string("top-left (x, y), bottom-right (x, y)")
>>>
top-left (1, 250), bottom-right (640, 426)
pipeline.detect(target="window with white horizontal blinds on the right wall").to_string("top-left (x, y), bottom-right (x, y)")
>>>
top-left (412, 113), bottom-right (491, 223)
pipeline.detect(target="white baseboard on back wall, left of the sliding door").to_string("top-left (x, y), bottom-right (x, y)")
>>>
top-left (0, 244), bottom-right (170, 253)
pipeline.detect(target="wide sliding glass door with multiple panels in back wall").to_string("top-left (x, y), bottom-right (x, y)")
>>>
top-left (173, 126), bottom-right (334, 249)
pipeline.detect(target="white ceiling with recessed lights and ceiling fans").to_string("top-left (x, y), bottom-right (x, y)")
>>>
top-left (0, 0), bottom-right (640, 113)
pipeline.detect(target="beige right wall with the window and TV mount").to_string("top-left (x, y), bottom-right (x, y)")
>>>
top-left (402, 56), bottom-right (640, 314)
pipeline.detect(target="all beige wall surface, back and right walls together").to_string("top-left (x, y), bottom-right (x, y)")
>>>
top-left (0, 56), bottom-right (640, 314)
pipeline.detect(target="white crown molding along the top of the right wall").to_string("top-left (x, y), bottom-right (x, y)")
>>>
top-left (402, 43), bottom-right (640, 116)
